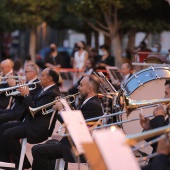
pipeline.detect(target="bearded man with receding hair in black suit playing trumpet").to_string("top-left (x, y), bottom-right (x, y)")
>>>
top-left (32, 75), bottom-right (103, 170)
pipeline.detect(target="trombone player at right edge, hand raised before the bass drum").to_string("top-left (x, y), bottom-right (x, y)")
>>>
top-left (140, 80), bottom-right (170, 152)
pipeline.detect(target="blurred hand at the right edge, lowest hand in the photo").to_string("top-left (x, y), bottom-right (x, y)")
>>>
top-left (157, 138), bottom-right (170, 155)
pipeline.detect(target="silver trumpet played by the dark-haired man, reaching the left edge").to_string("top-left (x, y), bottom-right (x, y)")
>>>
top-left (0, 81), bottom-right (41, 96)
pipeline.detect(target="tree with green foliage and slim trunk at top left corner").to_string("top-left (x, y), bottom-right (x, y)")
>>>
top-left (0, 0), bottom-right (60, 60)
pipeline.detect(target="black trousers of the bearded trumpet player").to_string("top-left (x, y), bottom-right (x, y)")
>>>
top-left (32, 143), bottom-right (68, 170)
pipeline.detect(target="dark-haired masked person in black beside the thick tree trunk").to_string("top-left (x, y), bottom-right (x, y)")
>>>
top-left (96, 44), bottom-right (115, 69)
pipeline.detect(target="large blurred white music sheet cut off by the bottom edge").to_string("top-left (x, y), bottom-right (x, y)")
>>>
top-left (93, 128), bottom-right (140, 170)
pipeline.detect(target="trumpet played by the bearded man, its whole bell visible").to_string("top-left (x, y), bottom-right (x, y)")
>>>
top-left (29, 92), bottom-right (80, 117)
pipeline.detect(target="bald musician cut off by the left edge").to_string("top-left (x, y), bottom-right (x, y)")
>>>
top-left (0, 59), bottom-right (14, 109)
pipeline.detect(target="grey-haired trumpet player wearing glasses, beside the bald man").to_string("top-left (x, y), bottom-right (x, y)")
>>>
top-left (0, 64), bottom-right (42, 124)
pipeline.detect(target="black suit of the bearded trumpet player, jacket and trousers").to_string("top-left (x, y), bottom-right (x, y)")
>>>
top-left (32, 96), bottom-right (103, 170)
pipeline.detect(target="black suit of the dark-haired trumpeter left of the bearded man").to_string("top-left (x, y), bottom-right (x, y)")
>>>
top-left (0, 85), bottom-right (60, 169)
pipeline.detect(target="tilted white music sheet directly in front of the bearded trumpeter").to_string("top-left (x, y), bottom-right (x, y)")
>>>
top-left (61, 110), bottom-right (93, 154)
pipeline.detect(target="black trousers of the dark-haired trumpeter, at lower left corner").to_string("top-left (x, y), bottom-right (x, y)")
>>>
top-left (0, 122), bottom-right (31, 168)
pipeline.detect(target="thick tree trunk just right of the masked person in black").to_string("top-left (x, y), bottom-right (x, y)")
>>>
top-left (110, 34), bottom-right (122, 67)
